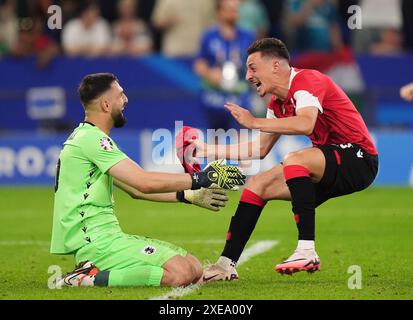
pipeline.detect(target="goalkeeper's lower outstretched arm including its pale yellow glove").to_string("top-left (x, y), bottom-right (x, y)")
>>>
top-left (114, 179), bottom-right (228, 211)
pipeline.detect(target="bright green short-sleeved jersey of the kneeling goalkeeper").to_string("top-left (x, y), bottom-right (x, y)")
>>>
top-left (50, 122), bottom-right (127, 254)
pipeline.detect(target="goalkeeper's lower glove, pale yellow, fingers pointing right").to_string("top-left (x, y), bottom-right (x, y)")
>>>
top-left (184, 188), bottom-right (228, 211)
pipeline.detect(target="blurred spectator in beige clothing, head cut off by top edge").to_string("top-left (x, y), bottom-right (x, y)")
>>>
top-left (152, 0), bottom-right (214, 57)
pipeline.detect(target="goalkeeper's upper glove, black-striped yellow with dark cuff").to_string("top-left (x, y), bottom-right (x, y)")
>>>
top-left (191, 160), bottom-right (246, 190)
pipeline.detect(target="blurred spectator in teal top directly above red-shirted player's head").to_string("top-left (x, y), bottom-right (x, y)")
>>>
top-left (238, 0), bottom-right (270, 39)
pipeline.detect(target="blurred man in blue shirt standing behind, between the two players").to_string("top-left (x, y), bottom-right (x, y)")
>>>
top-left (194, 0), bottom-right (255, 130)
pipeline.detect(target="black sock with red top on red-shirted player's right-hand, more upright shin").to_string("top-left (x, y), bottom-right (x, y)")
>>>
top-left (284, 165), bottom-right (315, 241)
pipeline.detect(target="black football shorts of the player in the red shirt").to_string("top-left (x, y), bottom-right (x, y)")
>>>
top-left (315, 143), bottom-right (379, 206)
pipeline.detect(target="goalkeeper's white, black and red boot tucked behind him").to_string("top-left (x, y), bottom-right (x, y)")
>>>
top-left (58, 261), bottom-right (99, 287)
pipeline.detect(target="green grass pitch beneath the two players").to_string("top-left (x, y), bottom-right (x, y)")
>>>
top-left (0, 188), bottom-right (413, 299)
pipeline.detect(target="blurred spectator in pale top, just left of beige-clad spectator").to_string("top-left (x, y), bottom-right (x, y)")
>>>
top-left (111, 0), bottom-right (152, 56)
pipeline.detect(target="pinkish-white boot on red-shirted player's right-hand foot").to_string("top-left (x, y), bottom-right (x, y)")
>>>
top-left (275, 249), bottom-right (321, 275)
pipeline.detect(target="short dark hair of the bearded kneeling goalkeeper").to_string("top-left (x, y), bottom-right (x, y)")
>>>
top-left (78, 73), bottom-right (119, 107)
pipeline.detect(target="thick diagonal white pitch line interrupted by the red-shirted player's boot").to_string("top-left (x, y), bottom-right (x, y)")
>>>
top-left (149, 240), bottom-right (278, 300)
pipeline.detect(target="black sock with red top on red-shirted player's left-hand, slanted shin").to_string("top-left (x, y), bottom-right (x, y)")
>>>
top-left (221, 189), bottom-right (266, 262)
